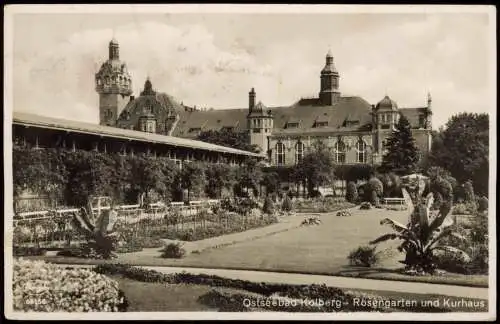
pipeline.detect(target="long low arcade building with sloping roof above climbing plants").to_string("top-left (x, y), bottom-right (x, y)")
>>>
top-left (12, 112), bottom-right (265, 166)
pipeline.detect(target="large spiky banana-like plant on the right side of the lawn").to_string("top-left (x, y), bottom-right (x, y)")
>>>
top-left (370, 189), bottom-right (469, 273)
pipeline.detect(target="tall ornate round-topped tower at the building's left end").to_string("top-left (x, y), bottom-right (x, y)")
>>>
top-left (95, 38), bottom-right (132, 126)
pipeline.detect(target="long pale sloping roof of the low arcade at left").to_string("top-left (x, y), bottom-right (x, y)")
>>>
top-left (12, 112), bottom-right (264, 158)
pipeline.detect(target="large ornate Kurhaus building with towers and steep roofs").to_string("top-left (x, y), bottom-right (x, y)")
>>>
top-left (96, 40), bottom-right (432, 166)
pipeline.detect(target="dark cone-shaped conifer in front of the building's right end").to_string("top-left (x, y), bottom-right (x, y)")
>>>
top-left (381, 115), bottom-right (419, 175)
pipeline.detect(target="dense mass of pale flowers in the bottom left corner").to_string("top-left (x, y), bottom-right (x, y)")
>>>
top-left (12, 259), bottom-right (128, 312)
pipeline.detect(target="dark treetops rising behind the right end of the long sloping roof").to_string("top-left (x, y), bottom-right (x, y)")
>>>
top-left (196, 129), bottom-right (260, 153)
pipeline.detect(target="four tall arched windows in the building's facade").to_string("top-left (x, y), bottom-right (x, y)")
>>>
top-left (275, 140), bottom-right (367, 165)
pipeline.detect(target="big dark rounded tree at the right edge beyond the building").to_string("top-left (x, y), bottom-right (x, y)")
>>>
top-left (430, 113), bottom-right (489, 195)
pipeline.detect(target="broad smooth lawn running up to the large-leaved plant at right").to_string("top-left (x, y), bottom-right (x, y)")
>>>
top-left (27, 209), bottom-right (488, 287)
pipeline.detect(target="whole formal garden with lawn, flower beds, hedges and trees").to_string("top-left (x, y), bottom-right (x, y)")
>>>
top-left (9, 116), bottom-right (490, 312)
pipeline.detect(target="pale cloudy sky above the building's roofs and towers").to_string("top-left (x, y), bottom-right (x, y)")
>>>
top-left (7, 7), bottom-right (496, 126)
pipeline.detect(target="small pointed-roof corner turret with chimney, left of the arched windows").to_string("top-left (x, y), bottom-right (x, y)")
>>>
top-left (247, 88), bottom-right (274, 153)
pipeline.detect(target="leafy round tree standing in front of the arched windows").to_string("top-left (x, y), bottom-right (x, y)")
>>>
top-left (294, 141), bottom-right (335, 195)
